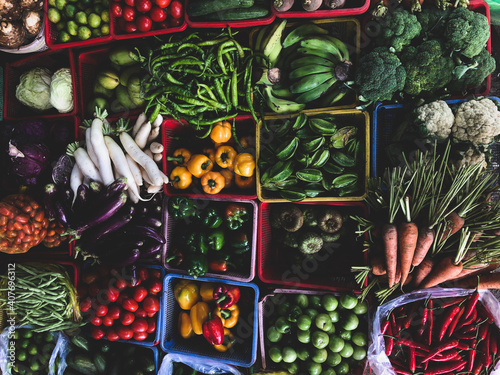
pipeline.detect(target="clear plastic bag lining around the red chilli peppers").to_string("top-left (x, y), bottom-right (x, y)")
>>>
top-left (367, 288), bottom-right (500, 375)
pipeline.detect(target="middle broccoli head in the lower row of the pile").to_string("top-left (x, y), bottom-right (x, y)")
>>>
top-left (401, 39), bottom-right (455, 95)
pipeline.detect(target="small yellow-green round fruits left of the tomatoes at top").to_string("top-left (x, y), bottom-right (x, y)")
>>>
top-left (47, 0), bottom-right (109, 43)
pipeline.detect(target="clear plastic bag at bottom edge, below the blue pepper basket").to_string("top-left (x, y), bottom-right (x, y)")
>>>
top-left (158, 353), bottom-right (243, 375)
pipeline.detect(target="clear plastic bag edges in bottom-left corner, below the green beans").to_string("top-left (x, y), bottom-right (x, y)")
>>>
top-left (0, 326), bottom-right (69, 375)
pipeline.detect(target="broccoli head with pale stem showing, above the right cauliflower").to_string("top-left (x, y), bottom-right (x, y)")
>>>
top-left (447, 48), bottom-right (496, 93)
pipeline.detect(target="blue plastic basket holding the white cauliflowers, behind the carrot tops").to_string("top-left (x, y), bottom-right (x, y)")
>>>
top-left (371, 96), bottom-right (500, 176)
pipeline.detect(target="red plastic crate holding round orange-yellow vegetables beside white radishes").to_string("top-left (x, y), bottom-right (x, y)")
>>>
top-left (162, 115), bottom-right (257, 199)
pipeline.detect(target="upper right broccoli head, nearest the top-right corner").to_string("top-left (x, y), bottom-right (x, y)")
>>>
top-left (444, 8), bottom-right (490, 58)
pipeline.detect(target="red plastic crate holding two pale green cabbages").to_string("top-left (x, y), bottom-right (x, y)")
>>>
top-left (3, 49), bottom-right (78, 120)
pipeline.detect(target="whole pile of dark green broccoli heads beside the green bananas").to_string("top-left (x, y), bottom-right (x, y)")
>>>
top-left (355, 6), bottom-right (496, 102)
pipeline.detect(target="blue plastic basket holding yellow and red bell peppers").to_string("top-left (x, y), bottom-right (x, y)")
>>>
top-left (160, 274), bottom-right (259, 367)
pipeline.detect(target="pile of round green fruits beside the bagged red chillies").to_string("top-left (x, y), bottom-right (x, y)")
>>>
top-left (264, 294), bottom-right (368, 375)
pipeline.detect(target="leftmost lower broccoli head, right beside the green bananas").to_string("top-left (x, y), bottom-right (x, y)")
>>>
top-left (355, 48), bottom-right (406, 101)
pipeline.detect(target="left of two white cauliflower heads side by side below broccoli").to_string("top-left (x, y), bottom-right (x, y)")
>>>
top-left (416, 100), bottom-right (455, 139)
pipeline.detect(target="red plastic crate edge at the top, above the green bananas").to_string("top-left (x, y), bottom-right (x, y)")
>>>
top-left (272, 0), bottom-right (370, 18)
